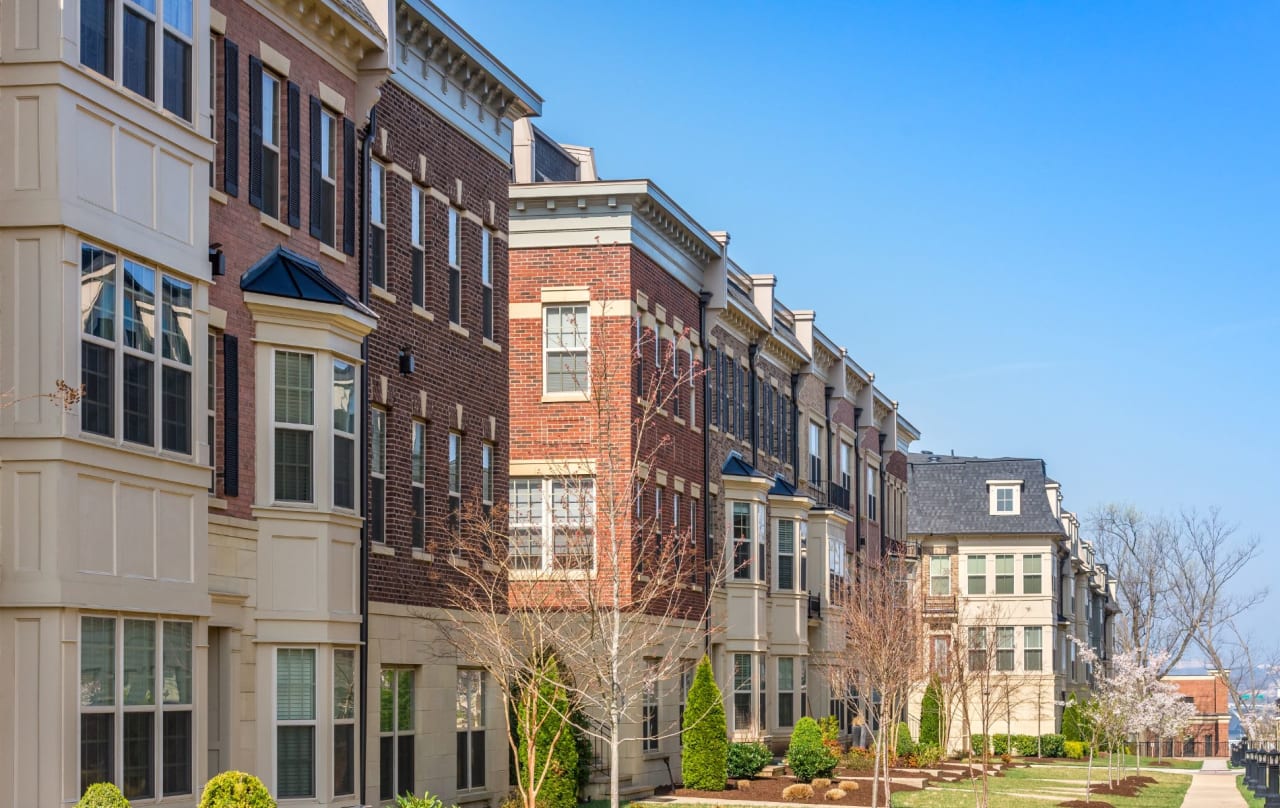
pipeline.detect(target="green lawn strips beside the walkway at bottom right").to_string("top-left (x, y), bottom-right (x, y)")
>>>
top-left (893, 766), bottom-right (1192, 808)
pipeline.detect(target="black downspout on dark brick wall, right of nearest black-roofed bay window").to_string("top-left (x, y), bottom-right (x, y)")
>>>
top-left (358, 104), bottom-right (378, 803)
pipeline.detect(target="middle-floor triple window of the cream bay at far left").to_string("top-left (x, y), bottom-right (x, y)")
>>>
top-left (81, 245), bottom-right (193, 455)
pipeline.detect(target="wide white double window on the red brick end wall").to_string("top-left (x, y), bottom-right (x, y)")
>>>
top-left (507, 478), bottom-right (595, 570)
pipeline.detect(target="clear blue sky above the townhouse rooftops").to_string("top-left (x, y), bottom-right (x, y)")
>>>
top-left (440, 0), bottom-right (1280, 642)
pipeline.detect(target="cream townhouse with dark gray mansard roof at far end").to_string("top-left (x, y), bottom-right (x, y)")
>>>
top-left (908, 452), bottom-right (1119, 749)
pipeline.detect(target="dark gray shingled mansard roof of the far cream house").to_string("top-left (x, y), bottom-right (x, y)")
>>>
top-left (908, 453), bottom-right (1062, 535)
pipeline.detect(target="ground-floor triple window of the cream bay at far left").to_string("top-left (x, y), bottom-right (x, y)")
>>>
top-left (79, 616), bottom-right (195, 800)
